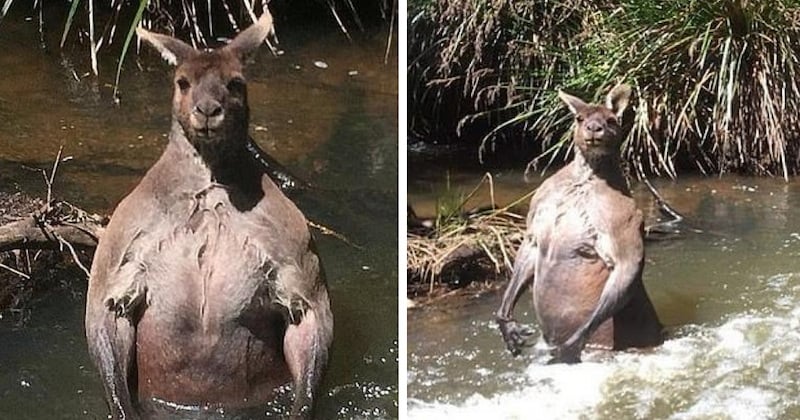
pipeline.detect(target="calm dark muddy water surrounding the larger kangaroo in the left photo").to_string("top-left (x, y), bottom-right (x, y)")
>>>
top-left (0, 9), bottom-right (398, 419)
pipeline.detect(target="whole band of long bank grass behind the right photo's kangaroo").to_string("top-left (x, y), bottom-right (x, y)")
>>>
top-left (408, 0), bottom-right (800, 177)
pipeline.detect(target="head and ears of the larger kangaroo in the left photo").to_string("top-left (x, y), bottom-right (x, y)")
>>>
top-left (136, 10), bottom-right (273, 152)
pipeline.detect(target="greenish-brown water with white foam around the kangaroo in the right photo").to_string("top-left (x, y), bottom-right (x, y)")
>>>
top-left (407, 169), bottom-right (800, 419)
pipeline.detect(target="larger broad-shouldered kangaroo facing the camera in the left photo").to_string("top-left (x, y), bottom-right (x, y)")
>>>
top-left (86, 10), bottom-right (333, 419)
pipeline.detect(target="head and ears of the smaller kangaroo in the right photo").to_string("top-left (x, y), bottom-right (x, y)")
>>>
top-left (558, 85), bottom-right (631, 159)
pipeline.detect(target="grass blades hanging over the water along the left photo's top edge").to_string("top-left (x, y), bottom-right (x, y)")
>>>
top-left (0, 0), bottom-right (397, 96)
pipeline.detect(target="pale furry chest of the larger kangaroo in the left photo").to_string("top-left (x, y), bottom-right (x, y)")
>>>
top-left (144, 185), bottom-right (294, 329)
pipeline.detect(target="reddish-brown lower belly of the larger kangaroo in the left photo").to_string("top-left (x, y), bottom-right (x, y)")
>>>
top-left (136, 310), bottom-right (290, 407)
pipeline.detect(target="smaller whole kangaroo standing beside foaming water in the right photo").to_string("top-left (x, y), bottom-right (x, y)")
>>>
top-left (496, 85), bottom-right (663, 363)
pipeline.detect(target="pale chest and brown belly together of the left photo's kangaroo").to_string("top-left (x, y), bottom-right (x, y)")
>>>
top-left (136, 197), bottom-right (290, 407)
